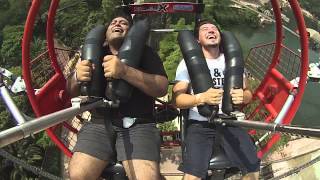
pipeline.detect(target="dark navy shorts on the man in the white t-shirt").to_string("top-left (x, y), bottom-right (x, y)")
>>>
top-left (179, 122), bottom-right (260, 178)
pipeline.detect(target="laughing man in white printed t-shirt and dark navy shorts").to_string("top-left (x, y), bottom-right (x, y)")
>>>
top-left (173, 20), bottom-right (260, 180)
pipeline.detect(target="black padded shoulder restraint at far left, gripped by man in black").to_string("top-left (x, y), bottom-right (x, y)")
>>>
top-left (81, 25), bottom-right (106, 97)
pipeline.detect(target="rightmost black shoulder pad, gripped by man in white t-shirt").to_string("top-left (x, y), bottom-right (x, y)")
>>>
top-left (221, 31), bottom-right (244, 115)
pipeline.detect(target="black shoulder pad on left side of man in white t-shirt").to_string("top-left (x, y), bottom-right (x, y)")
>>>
top-left (178, 30), bottom-right (219, 117)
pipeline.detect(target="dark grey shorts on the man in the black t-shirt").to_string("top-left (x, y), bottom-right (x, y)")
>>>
top-left (73, 118), bottom-right (160, 162)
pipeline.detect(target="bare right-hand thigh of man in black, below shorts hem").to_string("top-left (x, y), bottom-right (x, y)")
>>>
top-left (122, 159), bottom-right (160, 180)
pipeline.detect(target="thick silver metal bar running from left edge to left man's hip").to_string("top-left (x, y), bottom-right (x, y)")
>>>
top-left (0, 99), bottom-right (107, 148)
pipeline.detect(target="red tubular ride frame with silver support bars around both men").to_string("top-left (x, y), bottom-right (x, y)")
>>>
top-left (0, 0), bottom-right (320, 174)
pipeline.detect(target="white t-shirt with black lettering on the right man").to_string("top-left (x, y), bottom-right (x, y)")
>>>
top-left (175, 54), bottom-right (225, 121)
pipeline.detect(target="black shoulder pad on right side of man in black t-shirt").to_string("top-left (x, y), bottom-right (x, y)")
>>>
top-left (113, 19), bottom-right (150, 102)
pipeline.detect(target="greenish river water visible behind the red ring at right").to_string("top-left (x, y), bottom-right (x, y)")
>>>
top-left (226, 10), bottom-right (320, 127)
